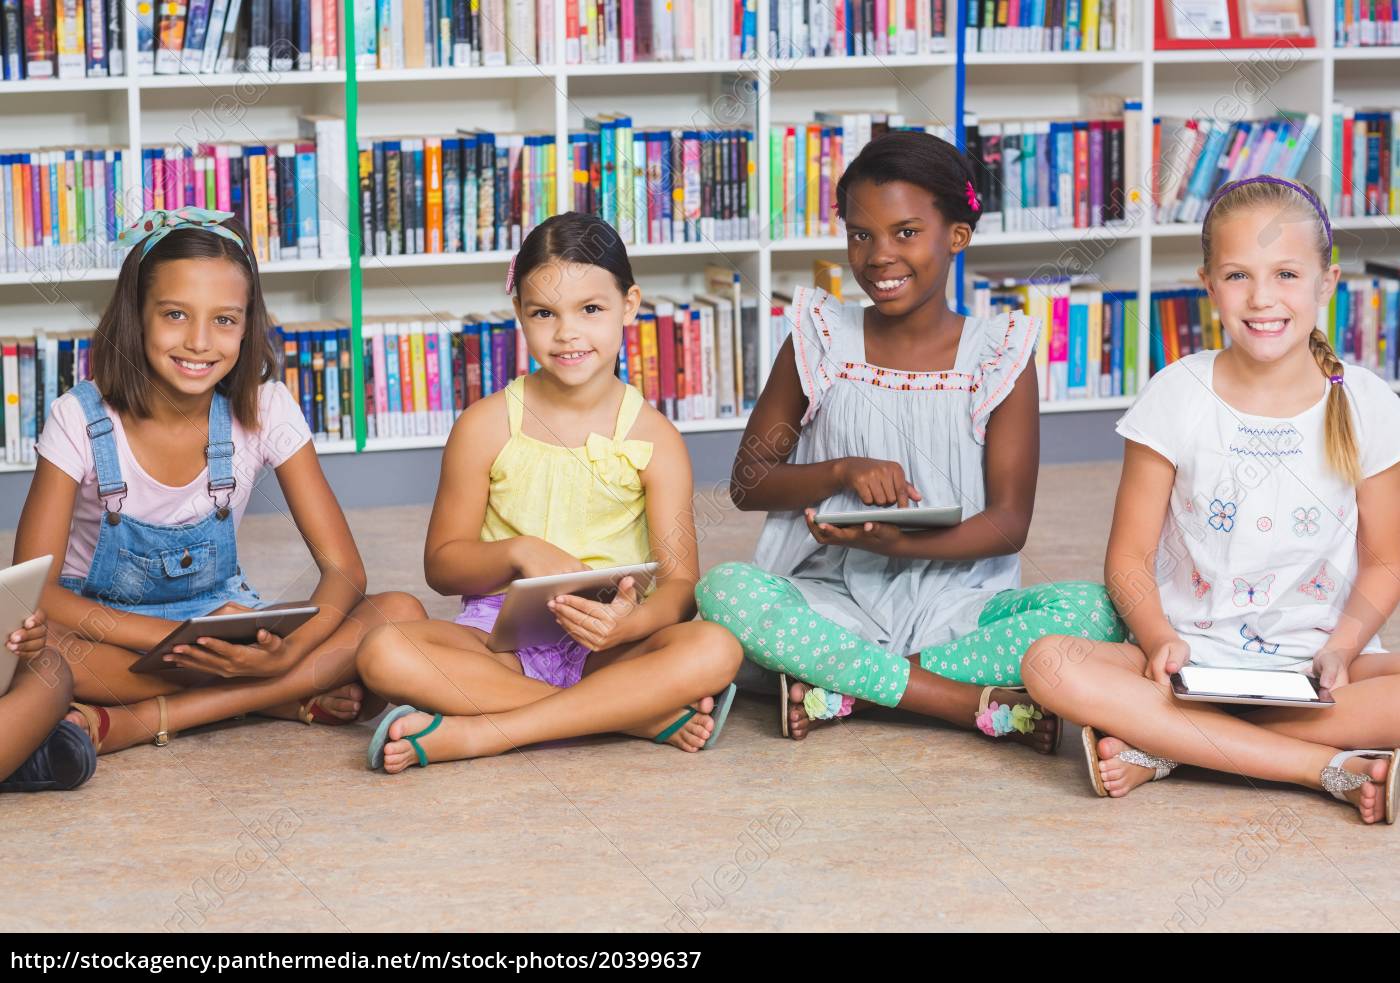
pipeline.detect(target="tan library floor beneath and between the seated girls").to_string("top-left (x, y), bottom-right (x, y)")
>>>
top-left (0, 465), bottom-right (1400, 933)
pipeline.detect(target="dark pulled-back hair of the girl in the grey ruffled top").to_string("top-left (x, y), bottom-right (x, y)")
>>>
top-left (836, 130), bottom-right (981, 228)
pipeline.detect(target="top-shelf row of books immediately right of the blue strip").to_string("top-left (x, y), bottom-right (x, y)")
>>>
top-left (966, 0), bottom-right (1145, 52)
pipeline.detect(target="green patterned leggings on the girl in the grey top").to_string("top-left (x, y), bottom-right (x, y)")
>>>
top-left (696, 563), bottom-right (1126, 707)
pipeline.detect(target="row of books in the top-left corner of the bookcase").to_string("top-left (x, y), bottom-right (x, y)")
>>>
top-left (0, 0), bottom-right (126, 81)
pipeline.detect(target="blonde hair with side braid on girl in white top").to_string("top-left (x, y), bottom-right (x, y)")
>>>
top-left (1201, 178), bottom-right (1361, 484)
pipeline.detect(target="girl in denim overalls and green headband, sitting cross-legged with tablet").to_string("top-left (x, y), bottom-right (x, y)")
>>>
top-left (14, 207), bottom-right (424, 753)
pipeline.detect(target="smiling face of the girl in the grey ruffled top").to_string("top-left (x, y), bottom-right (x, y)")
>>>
top-left (846, 181), bottom-right (972, 318)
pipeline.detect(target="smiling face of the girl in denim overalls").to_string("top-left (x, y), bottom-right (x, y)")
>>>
top-left (141, 259), bottom-right (249, 398)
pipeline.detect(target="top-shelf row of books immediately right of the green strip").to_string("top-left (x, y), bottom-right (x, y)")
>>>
top-left (354, 0), bottom-right (557, 69)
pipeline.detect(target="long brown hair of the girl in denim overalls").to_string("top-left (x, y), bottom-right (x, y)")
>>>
top-left (92, 218), bottom-right (277, 430)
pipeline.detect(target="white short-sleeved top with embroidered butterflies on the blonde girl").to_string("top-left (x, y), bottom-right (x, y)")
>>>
top-left (1117, 351), bottom-right (1400, 672)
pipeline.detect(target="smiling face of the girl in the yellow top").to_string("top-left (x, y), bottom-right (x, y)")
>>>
top-left (515, 262), bottom-right (641, 386)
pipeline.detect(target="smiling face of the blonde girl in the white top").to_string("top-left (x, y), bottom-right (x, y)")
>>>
top-left (1198, 202), bottom-right (1341, 363)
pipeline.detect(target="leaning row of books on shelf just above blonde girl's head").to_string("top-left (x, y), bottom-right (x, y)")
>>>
top-left (1152, 112), bottom-right (1322, 223)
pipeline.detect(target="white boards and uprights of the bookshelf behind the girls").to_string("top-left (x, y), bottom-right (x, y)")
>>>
top-left (0, 0), bottom-right (1400, 470)
